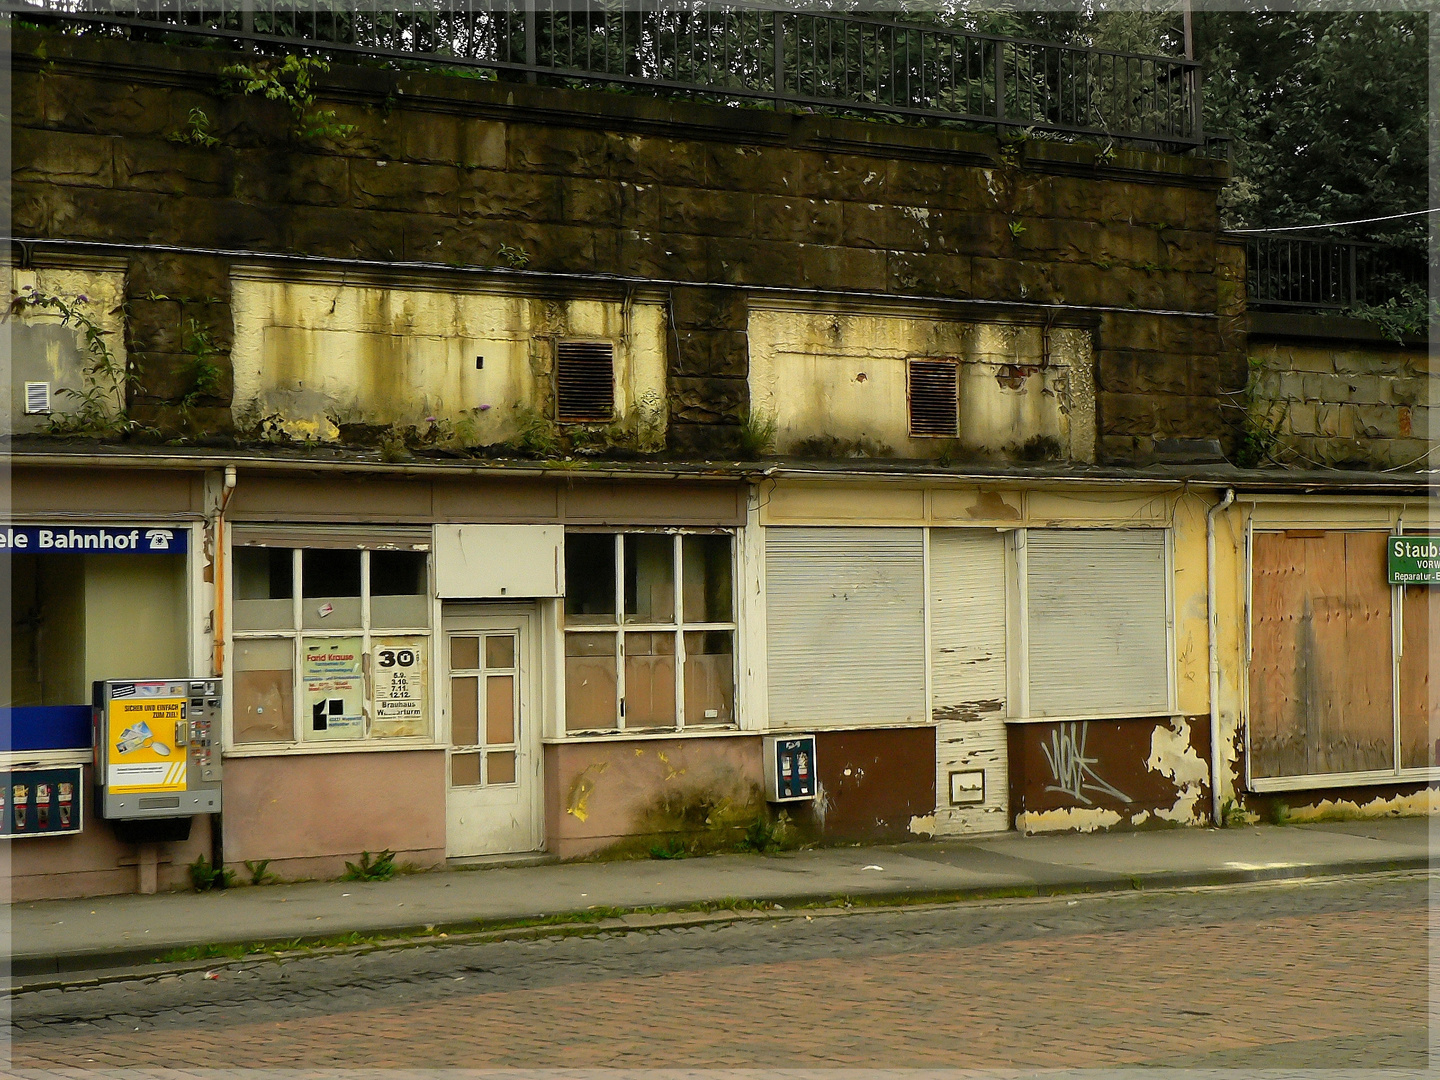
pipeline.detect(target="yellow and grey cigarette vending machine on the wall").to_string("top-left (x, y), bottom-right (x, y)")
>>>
top-left (95, 678), bottom-right (220, 819)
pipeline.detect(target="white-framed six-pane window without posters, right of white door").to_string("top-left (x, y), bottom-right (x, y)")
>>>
top-left (564, 531), bottom-right (734, 732)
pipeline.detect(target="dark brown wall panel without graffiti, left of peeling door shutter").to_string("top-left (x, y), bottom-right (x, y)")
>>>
top-left (788, 727), bottom-right (935, 841)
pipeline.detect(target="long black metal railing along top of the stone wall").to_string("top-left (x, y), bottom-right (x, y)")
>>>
top-left (0, 0), bottom-right (1204, 147)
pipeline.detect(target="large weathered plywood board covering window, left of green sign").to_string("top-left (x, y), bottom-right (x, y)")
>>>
top-left (1248, 530), bottom-right (1395, 778)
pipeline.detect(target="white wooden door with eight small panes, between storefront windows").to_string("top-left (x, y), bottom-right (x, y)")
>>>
top-left (442, 605), bottom-right (544, 858)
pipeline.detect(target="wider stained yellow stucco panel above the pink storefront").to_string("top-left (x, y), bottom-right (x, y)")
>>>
top-left (232, 272), bottom-right (665, 445)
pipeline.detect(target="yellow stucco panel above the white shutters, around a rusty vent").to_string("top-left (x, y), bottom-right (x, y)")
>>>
top-left (749, 308), bottom-right (1094, 461)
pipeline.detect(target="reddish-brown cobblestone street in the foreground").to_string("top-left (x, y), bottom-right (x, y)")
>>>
top-left (13, 874), bottom-right (1428, 1070)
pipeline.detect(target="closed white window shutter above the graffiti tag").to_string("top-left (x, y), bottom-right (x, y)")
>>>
top-left (1025, 528), bottom-right (1169, 716)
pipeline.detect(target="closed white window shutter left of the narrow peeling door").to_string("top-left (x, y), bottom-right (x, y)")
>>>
top-left (765, 527), bottom-right (926, 727)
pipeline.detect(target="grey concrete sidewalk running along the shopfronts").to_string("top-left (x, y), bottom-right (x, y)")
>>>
top-left (6, 818), bottom-right (1430, 976)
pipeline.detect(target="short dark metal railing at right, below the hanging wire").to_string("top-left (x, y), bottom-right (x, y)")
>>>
top-left (1244, 233), bottom-right (1427, 311)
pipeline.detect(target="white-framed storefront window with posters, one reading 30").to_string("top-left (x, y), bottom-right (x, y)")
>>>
top-left (232, 546), bottom-right (431, 744)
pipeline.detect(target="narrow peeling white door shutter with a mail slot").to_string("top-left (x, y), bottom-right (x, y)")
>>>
top-left (930, 528), bottom-right (1009, 835)
